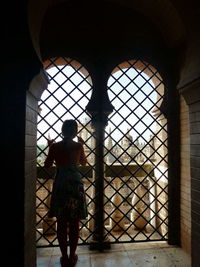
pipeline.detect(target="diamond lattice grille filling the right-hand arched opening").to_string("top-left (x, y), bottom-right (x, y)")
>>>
top-left (104, 61), bottom-right (168, 243)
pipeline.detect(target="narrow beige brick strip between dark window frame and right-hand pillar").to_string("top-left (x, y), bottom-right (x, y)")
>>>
top-left (180, 97), bottom-right (191, 253)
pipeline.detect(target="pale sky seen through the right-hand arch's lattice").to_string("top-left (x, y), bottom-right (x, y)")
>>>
top-left (108, 68), bottom-right (157, 141)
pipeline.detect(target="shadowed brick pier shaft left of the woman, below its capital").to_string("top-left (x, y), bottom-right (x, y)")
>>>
top-left (24, 92), bottom-right (37, 266)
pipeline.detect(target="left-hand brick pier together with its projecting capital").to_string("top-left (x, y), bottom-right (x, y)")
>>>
top-left (24, 73), bottom-right (47, 267)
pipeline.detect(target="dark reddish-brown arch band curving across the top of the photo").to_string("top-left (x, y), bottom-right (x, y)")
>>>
top-left (28, 0), bottom-right (186, 59)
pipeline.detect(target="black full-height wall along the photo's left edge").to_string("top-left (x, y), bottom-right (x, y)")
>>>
top-left (0, 1), bottom-right (41, 266)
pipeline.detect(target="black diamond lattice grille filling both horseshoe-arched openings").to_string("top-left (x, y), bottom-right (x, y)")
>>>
top-left (36, 58), bottom-right (168, 246)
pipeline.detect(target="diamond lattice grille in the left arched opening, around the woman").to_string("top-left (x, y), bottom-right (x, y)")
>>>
top-left (36, 58), bottom-right (94, 246)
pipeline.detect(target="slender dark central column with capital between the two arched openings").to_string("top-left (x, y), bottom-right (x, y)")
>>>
top-left (86, 66), bottom-right (113, 251)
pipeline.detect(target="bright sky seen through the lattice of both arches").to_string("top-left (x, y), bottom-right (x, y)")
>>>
top-left (37, 66), bottom-right (160, 144)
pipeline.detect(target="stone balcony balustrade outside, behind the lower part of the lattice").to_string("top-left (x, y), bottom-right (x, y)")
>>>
top-left (36, 163), bottom-right (168, 249)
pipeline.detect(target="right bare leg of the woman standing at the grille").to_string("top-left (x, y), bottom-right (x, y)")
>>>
top-left (69, 219), bottom-right (79, 262)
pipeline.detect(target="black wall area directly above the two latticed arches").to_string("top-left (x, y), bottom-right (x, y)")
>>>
top-left (40, 1), bottom-right (168, 64)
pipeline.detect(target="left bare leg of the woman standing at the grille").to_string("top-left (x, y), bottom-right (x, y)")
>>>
top-left (57, 215), bottom-right (68, 263)
